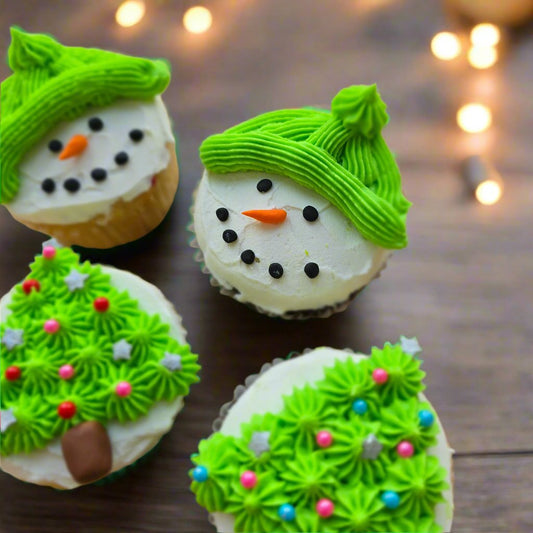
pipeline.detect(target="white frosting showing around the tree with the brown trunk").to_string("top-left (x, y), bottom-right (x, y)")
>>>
top-left (0, 266), bottom-right (186, 489)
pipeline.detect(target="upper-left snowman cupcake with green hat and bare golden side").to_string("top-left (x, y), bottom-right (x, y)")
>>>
top-left (0, 28), bottom-right (178, 248)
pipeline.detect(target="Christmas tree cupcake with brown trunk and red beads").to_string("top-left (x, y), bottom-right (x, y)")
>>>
top-left (0, 242), bottom-right (199, 489)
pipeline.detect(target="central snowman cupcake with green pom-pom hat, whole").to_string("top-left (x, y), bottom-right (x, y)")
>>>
top-left (192, 85), bottom-right (410, 318)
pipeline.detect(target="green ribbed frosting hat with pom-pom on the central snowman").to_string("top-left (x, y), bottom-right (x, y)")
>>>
top-left (200, 85), bottom-right (410, 249)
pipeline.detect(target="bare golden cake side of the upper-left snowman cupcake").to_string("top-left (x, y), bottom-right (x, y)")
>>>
top-left (15, 141), bottom-right (179, 248)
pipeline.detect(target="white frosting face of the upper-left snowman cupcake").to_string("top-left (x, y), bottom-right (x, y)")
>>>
top-left (7, 96), bottom-right (174, 224)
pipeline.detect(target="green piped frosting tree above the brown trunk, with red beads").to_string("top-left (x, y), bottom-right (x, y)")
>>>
top-left (0, 243), bottom-right (199, 456)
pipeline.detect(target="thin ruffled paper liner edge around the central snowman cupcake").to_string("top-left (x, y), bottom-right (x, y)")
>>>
top-left (187, 188), bottom-right (392, 320)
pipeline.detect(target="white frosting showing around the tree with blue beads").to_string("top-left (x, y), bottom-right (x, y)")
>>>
top-left (212, 347), bottom-right (453, 533)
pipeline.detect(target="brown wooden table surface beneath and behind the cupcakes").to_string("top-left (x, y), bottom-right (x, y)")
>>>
top-left (0, 0), bottom-right (533, 533)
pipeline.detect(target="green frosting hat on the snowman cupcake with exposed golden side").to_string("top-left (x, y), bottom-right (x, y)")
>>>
top-left (0, 27), bottom-right (170, 203)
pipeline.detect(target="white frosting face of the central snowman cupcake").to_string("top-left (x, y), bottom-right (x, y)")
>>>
top-left (193, 171), bottom-right (391, 314)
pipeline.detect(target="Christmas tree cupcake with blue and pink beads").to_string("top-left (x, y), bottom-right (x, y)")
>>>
top-left (190, 338), bottom-right (453, 533)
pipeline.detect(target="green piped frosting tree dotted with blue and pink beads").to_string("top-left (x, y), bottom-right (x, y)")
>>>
top-left (191, 343), bottom-right (448, 533)
